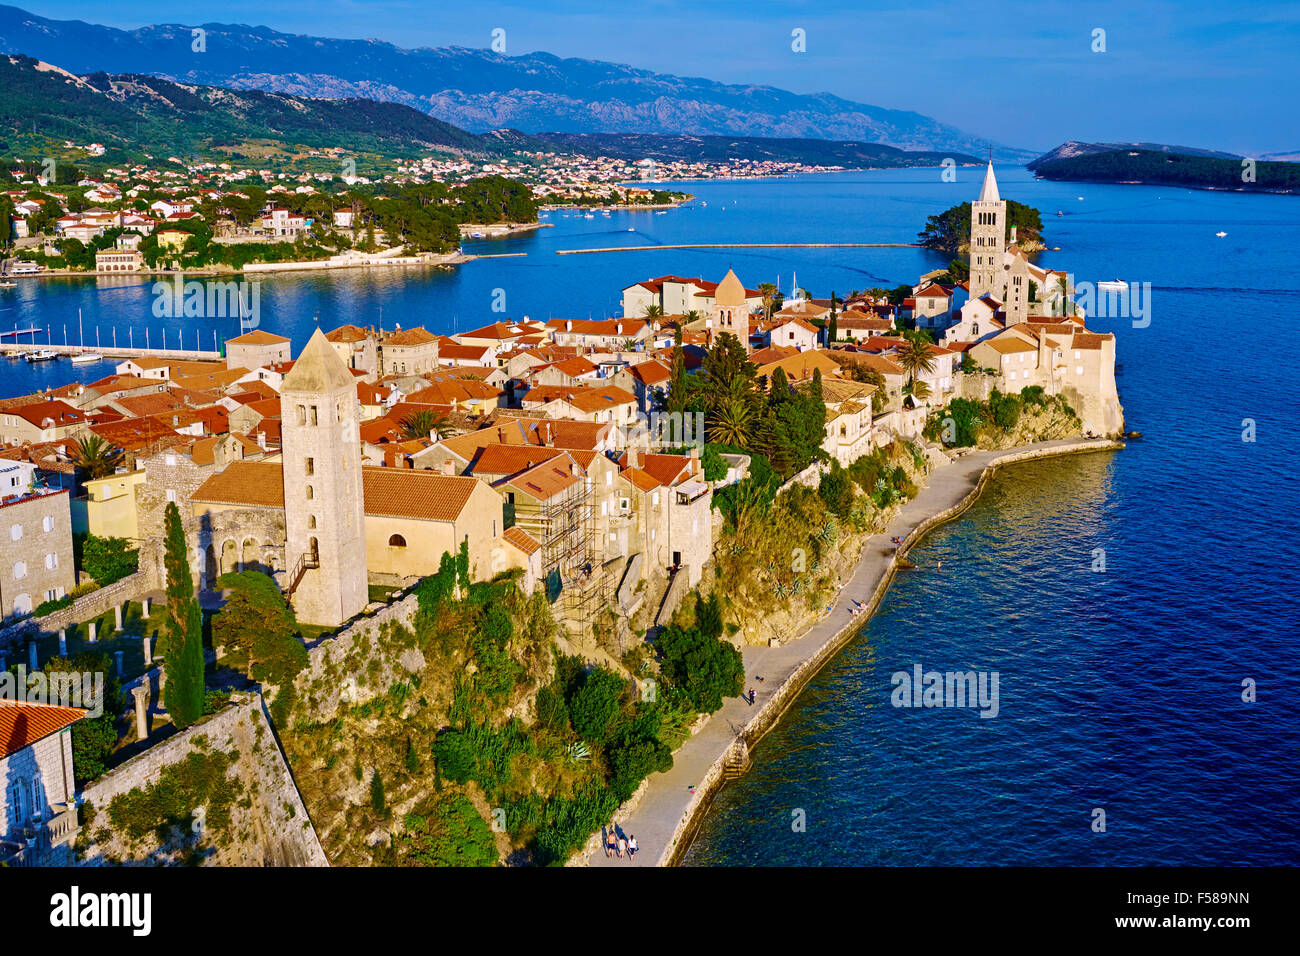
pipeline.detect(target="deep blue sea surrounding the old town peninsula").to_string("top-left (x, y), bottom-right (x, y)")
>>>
top-left (0, 168), bottom-right (1300, 865)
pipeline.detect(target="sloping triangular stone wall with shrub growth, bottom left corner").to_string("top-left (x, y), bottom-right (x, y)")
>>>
top-left (78, 695), bottom-right (329, 866)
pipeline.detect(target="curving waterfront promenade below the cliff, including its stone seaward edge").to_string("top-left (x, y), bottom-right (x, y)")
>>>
top-left (585, 438), bottom-right (1123, 866)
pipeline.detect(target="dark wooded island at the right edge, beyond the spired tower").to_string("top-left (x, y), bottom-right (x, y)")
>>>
top-left (1028, 143), bottom-right (1300, 193)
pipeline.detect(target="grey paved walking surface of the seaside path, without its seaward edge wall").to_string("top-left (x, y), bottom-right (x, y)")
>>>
top-left (588, 438), bottom-right (1118, 866)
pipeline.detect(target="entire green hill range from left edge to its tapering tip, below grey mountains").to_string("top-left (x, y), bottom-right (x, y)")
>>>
top-left (0, 55), bottom-right (976, 176)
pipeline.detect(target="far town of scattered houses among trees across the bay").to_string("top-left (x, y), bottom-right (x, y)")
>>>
top-left (0, 142), bottom-right (835, 277)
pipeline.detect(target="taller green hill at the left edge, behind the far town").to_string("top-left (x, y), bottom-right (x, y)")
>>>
top-left (0, 55), bottom-right (502, 167)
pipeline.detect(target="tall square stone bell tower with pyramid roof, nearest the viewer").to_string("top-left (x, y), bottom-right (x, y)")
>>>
top-left (280, 329), bottom-right (368, 627)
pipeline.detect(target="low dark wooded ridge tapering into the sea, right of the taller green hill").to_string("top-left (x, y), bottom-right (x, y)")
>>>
top-left (517, 133), bottom-right (980, 169)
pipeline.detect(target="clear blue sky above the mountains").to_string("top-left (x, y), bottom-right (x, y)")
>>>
top-left (9, 0), bottom-right (1300, 155)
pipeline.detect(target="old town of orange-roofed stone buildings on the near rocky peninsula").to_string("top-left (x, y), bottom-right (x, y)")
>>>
top-left (0, 164), bottom-right (1125, 865)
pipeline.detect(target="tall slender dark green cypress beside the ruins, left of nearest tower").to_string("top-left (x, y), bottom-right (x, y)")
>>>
top-left (164, 502), bottom-right (204, 730)
